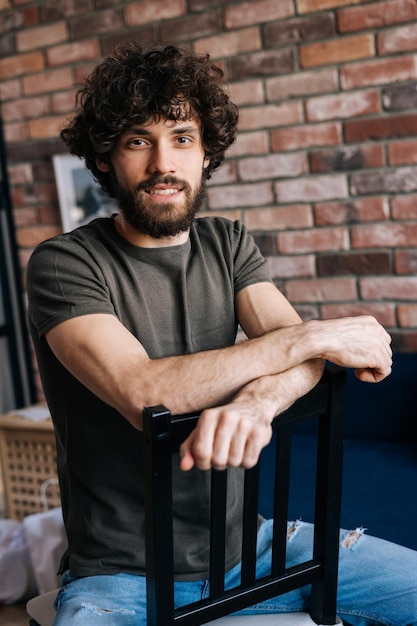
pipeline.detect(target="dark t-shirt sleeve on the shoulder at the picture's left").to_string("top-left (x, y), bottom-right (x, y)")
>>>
top-left (27, 237), bottom-right (115, 338)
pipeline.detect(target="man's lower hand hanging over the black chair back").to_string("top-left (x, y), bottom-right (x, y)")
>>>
top-left (180, 402), bottom-right (272, 471)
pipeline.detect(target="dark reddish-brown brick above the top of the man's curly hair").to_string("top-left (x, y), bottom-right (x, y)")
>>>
top-left (160, 11), bottom-right (222, 43)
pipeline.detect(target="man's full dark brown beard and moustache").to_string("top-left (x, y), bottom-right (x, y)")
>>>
top-left (113, 174), bottom-right (206, 239)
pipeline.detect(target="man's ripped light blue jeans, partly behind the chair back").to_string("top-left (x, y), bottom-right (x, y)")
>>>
top-left (54, 520), bottom-right (417, 626)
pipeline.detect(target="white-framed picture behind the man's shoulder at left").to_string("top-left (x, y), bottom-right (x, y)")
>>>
top-left (53, 154), bottom-right (118, 232)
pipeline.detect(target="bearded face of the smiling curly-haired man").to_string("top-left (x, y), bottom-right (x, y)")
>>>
top-left (99, 114), bottom-right (208, 239)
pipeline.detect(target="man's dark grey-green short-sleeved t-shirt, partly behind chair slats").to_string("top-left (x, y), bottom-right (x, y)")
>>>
top-left (27, 218), bottom-right (270, 580)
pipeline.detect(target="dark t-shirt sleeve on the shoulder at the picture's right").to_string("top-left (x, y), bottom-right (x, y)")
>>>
top-left (229, 221), bottom-right (272, 294)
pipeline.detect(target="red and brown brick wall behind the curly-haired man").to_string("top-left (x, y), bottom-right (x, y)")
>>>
top-left (0, 0), bottom-right (417, 360)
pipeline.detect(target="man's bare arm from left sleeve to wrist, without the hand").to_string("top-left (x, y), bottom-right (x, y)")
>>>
top-left (47, 315), bottom-right (322, 428)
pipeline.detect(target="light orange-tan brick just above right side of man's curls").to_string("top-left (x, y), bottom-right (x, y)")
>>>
top-left (194, 27), bottom-right (262, 59)
